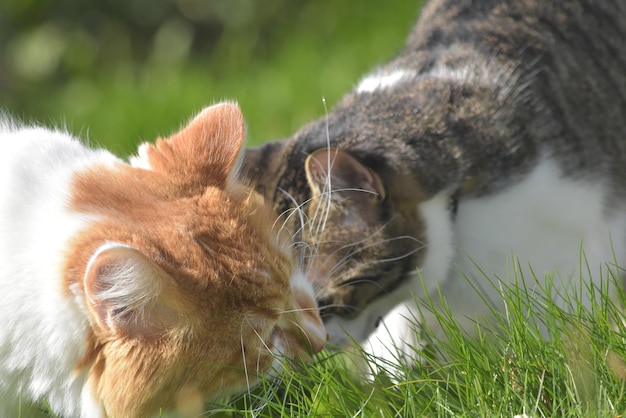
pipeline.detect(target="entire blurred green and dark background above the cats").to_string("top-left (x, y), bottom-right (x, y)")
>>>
top-left (0, 0), bottom-right (419, 155)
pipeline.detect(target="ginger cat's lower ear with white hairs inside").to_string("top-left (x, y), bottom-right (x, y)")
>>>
top-left (84, 243), bottom-right (179, 336)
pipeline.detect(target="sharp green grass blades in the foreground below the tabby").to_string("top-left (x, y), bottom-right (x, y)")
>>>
top-left (206, 264), bottom-right (626, 417)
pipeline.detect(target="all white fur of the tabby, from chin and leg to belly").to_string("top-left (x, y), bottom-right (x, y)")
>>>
top-left (327, 159), bottom-right (626, 370)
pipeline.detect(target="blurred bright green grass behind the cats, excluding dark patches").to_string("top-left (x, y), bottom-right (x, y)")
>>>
top-left (0, 0), bottom-right (419, 155)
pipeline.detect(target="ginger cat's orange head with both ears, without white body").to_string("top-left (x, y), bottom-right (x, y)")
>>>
top-left (65, 103), bottom-right (325, 417)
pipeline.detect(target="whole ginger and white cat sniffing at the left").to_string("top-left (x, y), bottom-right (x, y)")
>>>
top-left (0, 103), bottom-right (326, 418)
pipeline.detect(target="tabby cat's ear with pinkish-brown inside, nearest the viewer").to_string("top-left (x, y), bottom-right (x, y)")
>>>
top-left (305, 148), bottom-right (385, 201)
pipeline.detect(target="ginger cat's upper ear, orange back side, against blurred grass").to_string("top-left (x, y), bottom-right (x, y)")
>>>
top-left (133, 102), bottom-right (245, 187)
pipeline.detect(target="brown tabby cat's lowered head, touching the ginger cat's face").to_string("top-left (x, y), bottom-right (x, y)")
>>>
top-left (243, 111), bottom-right (425, 319)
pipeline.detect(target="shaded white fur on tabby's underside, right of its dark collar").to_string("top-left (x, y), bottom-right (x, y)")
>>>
top-left (456, 159), bottom-right (626, 311)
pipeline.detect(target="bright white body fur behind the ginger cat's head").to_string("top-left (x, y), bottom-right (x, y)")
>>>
top-left (0, 121), bottom-right (117, 417)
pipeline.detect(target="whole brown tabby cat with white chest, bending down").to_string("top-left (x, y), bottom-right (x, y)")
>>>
top-left (245, 0), bottom-right (626, 362)
